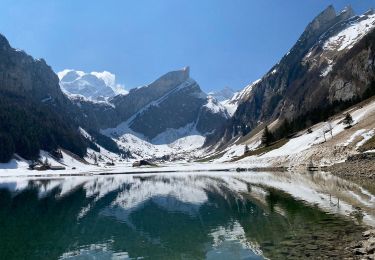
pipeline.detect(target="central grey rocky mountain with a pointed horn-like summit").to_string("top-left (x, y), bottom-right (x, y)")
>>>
top-left (100, 67), bottom-right (228, 140)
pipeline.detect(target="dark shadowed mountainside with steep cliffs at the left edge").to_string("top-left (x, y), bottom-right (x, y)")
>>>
top-left (0, 35), bottom-right (88, 161)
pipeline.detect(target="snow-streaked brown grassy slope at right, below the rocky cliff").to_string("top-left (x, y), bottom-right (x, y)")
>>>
top-left (216, 100), bottom-right (375, 166)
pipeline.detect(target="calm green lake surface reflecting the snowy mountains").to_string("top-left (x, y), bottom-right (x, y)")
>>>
top-left (0, 172), bottom-right (375, 259)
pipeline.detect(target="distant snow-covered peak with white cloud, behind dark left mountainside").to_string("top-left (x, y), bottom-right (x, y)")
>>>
top-left (57, 70), bottom-right (127, 100)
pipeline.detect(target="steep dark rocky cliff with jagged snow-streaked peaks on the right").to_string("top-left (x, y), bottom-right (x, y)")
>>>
top-left (226, 6), bottom-right (375, 136)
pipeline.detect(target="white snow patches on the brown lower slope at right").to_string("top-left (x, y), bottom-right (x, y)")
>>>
top-left (215, 99), bottom-right (375, 167)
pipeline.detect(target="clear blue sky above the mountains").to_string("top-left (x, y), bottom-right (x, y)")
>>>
top-left (0, 0), bottom-right (375, 91)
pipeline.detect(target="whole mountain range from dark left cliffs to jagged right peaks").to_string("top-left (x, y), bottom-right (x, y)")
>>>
top-left (0, 6), bottom-right (375, 164)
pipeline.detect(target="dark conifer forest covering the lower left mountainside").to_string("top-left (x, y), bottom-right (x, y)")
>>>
top-left (0, 92), bottom-right (88, 162)
